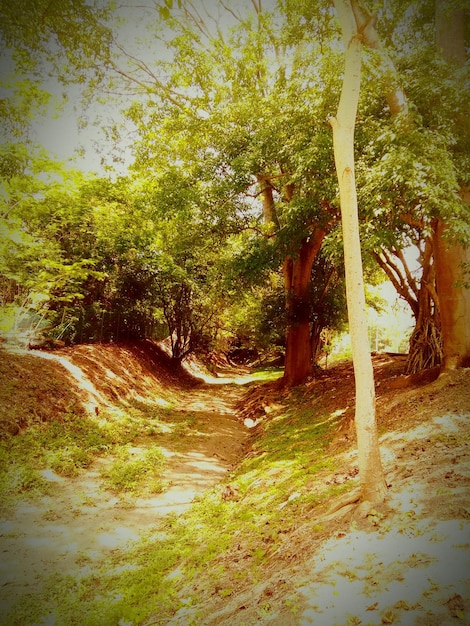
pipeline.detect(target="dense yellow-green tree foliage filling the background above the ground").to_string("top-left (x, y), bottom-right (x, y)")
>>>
top-left (0, 0), bottom-right (470, 366)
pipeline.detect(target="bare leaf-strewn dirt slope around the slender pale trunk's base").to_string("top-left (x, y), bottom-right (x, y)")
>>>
top-left (188, 366), bottom-right (470, 626)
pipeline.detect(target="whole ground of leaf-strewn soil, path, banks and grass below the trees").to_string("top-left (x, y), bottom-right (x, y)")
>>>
top-left (0, 346), bottom-right (470, 626)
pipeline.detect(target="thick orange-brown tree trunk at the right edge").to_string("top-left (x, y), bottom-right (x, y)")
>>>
top-left (434, 0), bottom-right (470, 371)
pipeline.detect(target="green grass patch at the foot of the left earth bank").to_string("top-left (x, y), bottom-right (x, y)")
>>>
top-left (0, 398), bottom-right (199, 510)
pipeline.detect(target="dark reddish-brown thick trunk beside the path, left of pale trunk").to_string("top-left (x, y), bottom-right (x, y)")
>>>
top-left (282, 228), bottom-right (326, 387)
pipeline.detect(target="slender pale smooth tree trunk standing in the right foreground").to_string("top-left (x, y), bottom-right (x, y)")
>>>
top-left (330, 0), bottom-right (386, 503)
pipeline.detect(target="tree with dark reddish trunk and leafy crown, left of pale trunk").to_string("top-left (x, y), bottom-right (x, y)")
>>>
top-left (121, 3), bottom-right (337, 386)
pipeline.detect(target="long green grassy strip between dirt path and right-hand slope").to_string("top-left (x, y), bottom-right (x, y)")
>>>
top-left (5, 378), bottom-right (352, 626)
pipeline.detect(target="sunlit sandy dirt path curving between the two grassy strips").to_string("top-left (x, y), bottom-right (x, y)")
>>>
top-left (0, 384), bottom-right (249, 622)
